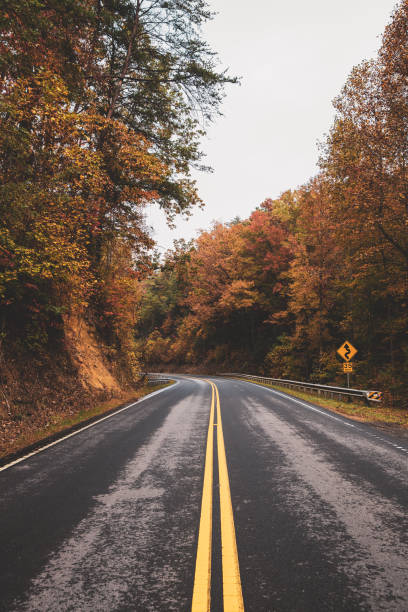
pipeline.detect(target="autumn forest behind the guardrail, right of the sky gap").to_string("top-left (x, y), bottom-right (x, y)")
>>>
top-left (137, 2), bottom-right (408, 400)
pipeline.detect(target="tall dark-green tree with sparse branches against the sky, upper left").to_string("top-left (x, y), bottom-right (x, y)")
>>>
top-left (80, 0), bottom-right (236, 218)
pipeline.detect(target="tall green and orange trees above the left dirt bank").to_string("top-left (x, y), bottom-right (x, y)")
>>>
top-left (0, 0), bottom-right (235, 358)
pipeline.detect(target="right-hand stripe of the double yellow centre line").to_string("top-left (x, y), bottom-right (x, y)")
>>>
top-left (212, 383), bottom-right (244, 612)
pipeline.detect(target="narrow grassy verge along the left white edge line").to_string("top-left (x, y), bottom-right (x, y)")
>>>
top-left (0, 382), bottom-right (174, 460)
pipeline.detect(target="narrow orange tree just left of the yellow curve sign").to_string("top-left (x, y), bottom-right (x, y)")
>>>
top-left (284, 176), bottom-right (346, 379)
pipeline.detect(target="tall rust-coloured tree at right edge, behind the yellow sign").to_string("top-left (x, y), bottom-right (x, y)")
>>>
top-left (322, 1), bottom-right (408, 384)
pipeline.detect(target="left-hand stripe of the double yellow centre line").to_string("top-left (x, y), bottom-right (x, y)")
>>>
top-left (191, 387), bottom-right (215, 612)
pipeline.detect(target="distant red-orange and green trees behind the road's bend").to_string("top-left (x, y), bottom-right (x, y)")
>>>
top-left (139, 201), bottom-right (290, 370)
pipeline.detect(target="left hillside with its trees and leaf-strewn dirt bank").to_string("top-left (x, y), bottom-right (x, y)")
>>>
top-left (0, 0), bottom-right (235, 450)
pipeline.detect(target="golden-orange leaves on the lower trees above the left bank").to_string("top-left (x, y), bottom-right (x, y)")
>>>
top-left (0, 55), bottom-right (167, 340)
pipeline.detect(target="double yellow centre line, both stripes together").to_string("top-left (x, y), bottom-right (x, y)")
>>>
top-left (191, 381), bottom-right (244, 612)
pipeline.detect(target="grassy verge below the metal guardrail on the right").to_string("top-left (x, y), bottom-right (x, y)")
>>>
top-left (242, 379), bottom-right (408, 429)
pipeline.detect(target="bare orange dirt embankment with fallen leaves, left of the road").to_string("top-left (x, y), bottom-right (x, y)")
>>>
top-left (0, 316), bottom-right (136, 456)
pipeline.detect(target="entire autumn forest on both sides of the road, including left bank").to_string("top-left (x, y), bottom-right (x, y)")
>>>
top-left (0, 0), bottom-right (408, 448)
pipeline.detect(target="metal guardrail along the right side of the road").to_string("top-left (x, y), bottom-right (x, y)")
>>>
top-left (219, 372), bottom-right (382, 402)
